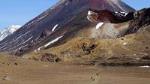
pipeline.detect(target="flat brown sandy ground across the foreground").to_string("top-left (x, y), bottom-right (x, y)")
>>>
top-left (0, 57), bottom-right (150, 84)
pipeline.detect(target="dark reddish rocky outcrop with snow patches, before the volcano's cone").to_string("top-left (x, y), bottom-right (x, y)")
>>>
top-left (87, 9), bottom-right (134, 23)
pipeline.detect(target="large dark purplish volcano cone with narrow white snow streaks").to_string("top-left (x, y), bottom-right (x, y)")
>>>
top-left (0, 0), bottom-right (135, 55)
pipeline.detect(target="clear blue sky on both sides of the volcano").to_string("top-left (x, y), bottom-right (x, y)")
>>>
top-left (0, 0), bottom-right (150, 29)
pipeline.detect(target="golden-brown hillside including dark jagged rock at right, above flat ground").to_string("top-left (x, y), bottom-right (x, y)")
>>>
top-left (24, 8), bottom-right (150, 65)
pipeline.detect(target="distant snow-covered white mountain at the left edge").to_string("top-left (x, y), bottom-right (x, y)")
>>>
top-left (0, 25), bottom-right (21, 41)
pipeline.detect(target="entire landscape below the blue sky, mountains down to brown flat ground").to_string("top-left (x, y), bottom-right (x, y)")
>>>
top-left (0, 0), bottom-right (150, 84)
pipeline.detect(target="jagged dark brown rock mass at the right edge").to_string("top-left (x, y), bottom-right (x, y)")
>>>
top-left (126, 8), bottom-right (150, 34)
